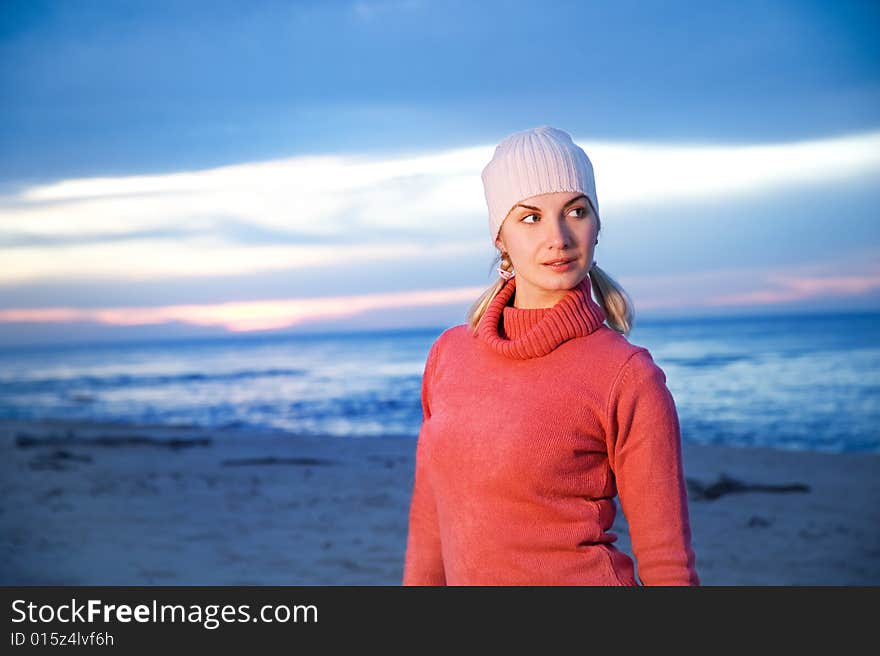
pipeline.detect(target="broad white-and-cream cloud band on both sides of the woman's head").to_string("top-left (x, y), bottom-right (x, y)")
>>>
top-left (0, 132), bottom-right (880, 284)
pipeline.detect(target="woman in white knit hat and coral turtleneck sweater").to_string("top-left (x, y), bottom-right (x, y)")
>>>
top-left (403, 126), bottom-right (699, 585)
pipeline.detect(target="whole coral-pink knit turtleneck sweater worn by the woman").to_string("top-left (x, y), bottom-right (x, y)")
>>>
top-left (403, 277), bottom-right (699, 585)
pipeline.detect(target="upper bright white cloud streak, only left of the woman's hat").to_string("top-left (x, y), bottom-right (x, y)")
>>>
top-left (0, 148), bottom-right (486, 242)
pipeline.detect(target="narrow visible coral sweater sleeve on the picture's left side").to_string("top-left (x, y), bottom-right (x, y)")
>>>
top-left (403, 342), bottom-right (446, 586)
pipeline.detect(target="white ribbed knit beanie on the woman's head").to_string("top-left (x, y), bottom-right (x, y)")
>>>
top-left (482, 125), bottom-right (599, 244)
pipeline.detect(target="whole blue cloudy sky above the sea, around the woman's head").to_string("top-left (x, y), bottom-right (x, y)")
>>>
top-left (0, 0), bottom-right (880, 346)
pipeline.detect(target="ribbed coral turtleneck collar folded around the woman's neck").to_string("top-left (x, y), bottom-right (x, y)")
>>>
top-left (477, 275), bottom-right (606, 360)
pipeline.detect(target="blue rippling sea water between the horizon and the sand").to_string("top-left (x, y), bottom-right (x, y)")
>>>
top-left (0, 314), bottom-right (880, 453)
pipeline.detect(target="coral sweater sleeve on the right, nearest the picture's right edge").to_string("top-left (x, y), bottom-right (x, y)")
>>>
top-left (608, 348), bottom-right (700, 585)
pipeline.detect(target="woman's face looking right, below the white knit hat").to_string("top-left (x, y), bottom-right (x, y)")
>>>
top-left (495, 191), bottom-right (599, 308)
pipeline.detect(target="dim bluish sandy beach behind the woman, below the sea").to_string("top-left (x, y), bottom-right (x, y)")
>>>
top-left (0, 420), bottom-right (880, 585)
